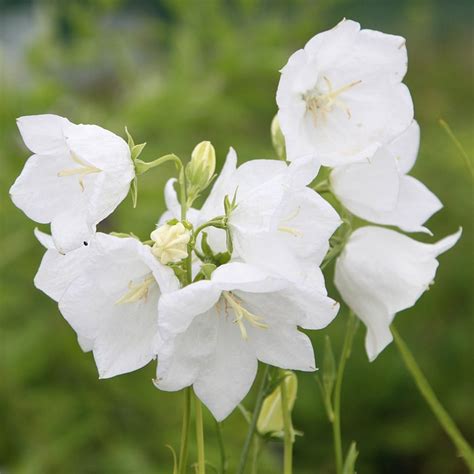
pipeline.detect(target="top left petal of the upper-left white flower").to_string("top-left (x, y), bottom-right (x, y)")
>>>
top-left (16, 114), bottom-right (73, 155)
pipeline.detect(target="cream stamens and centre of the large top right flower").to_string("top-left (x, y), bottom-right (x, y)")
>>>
top-left (303, 76), bottom-right (362, 127)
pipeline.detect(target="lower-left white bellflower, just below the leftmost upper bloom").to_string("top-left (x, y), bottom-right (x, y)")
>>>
top-left (35, 233), bottom-right (178, 378)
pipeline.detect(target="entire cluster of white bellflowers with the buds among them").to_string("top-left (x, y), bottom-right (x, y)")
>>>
top-left (11, 20), bottom-right (460, 420)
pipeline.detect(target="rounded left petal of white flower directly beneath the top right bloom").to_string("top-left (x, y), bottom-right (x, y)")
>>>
top-left (330, 148), bottom-right (400, 214)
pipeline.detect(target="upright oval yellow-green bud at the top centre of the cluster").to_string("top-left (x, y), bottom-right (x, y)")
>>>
top-left (186, 141), bottom-right (216, 196)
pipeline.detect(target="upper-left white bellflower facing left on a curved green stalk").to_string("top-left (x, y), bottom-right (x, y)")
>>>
top-left (10, 115), bottom-right (134, 252)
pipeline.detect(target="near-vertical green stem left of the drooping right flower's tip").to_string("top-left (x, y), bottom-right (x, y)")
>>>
top-left (332, 311), bottom-right (356, 474)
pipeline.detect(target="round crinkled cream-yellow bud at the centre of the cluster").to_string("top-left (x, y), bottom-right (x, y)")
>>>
top-left (150, 222), bottom-right (191, 265)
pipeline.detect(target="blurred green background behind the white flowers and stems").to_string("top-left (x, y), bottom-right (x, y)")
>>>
top-left (0, 0), bottom-right (474, 474)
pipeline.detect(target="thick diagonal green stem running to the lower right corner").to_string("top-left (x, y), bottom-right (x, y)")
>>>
top-left (391, 325), bottom-right (474, 472)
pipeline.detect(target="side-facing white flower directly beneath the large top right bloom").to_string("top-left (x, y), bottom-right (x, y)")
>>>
top-left (330, 121), bottom-right (442, 233)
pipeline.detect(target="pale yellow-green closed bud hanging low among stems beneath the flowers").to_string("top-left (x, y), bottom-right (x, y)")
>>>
top-left (257, 371), bottom-right (298, 436)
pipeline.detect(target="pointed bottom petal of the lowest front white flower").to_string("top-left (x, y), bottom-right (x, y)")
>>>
top-left (194, 318), bottom-right (257, 421)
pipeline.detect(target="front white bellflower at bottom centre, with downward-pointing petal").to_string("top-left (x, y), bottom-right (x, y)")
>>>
top-left (155, 262), bottom-right (338, 420)
